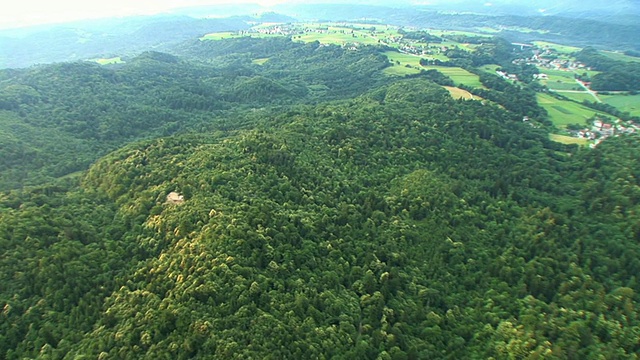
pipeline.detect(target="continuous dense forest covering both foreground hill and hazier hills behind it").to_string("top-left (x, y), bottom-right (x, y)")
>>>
top-left (0, 33), bottom-right (640, 359)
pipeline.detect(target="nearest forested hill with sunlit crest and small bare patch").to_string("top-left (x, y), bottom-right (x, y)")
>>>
top-left (0, 79), bottom-right (640, 359)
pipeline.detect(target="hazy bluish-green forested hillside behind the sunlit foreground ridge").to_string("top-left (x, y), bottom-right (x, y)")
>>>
top-left (0, 38), bottom-right (389, 190)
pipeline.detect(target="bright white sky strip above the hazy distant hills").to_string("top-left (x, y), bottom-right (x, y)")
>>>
top-left (0, 0), bottom-right (283, 29)
